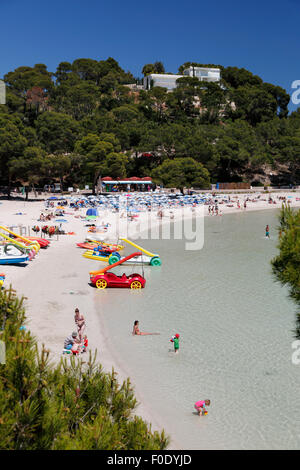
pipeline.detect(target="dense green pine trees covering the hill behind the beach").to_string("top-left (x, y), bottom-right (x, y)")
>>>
top-left (0, 57), bottom-right (300, 190)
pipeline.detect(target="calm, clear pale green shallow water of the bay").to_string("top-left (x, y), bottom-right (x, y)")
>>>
top-left (95, 210), bottom-right (300, 449)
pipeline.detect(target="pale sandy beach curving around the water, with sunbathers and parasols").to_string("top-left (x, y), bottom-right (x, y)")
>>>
top-left (0, 190), bottom-right (300, 448)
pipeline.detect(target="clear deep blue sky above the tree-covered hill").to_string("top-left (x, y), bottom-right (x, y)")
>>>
top-left (0, 0), bottom-right (300, 109)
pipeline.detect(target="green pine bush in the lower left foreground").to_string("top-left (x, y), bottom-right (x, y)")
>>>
top-left (0, 288), bottom-right (168, 450)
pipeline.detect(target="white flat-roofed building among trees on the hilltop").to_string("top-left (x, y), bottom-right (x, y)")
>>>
top-left (144, 67), bottom-right (221, 90)
